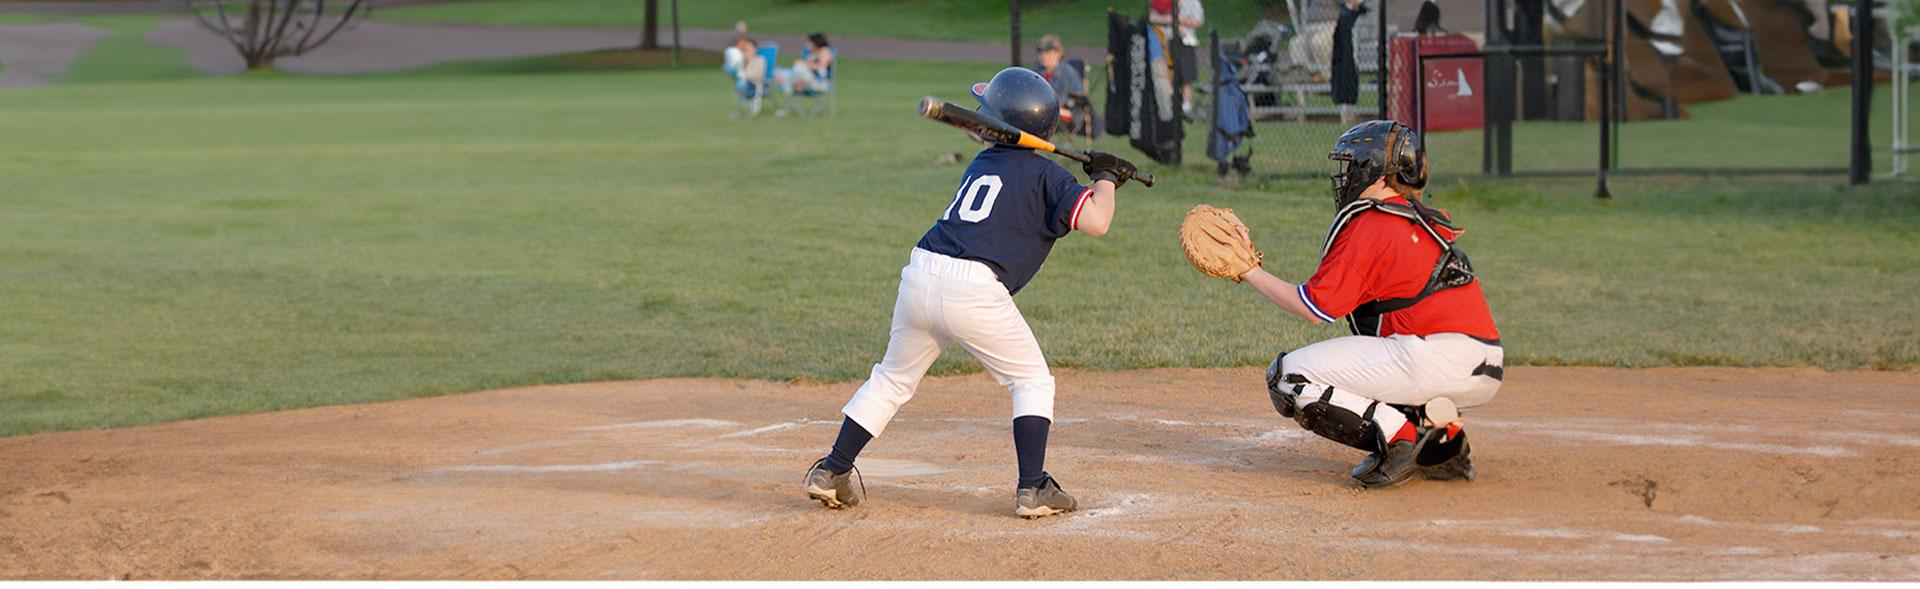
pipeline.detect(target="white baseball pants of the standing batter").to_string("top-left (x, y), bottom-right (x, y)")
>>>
top-left (841, 247), bottom-right (1054, 437)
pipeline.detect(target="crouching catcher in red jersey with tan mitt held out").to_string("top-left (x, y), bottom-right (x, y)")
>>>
top-left (1181, 121), bottom-right (1503, 487)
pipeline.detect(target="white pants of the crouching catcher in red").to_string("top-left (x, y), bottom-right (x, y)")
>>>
top-left (1281, 334), bottom-right (1505, 443)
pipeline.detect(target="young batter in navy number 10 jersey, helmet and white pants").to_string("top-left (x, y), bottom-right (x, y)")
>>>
top-left (806, 67), bottom-right (1135, 518)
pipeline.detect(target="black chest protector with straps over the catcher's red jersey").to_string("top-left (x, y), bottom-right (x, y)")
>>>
top-left (1321, 198), bottom-right (1473, 336)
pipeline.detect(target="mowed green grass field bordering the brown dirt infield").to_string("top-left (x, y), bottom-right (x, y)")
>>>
top-left (0, 61), bottom-right (1920, 436)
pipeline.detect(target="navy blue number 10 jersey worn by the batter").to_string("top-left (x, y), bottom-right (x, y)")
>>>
top-left (918, 146), bottom-right (1092, 294)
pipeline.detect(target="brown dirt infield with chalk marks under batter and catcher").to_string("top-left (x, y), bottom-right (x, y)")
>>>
top-left (0, 368), bottom-right (1920, 579)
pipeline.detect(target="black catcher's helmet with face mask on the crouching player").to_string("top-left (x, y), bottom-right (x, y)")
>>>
top-left (1327, 121), bottom-right (1427, 207)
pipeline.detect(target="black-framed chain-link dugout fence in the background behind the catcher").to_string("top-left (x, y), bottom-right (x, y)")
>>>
top-left (1010, 0), bottom-right (1916, 187)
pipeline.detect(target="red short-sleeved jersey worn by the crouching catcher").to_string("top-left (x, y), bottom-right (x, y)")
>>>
top-left (1300, 196), bottom-right (1500, 340)
